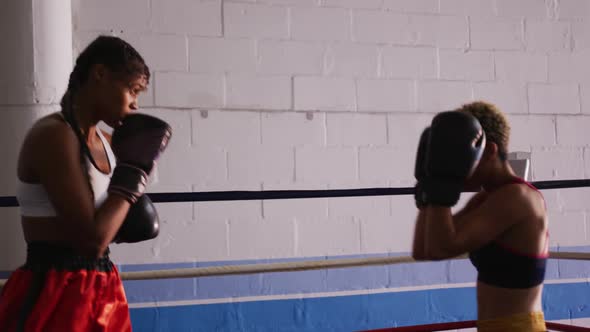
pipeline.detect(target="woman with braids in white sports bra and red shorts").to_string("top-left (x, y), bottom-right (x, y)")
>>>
top-left (0, 36), bottom-right (171, 331)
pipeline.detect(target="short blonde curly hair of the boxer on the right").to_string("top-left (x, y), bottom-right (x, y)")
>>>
top-left (458, 100), bottom-right (510, 160)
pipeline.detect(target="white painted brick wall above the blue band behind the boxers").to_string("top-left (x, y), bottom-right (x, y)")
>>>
top-left (73, 0), bottom-right (590, 263)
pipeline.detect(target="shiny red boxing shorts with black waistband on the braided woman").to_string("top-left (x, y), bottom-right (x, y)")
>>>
top-left (0, 243), bottom-right (131, 332)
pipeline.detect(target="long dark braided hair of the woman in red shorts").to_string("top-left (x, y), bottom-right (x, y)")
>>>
top-left (60, 36), bottom-right (150, 200)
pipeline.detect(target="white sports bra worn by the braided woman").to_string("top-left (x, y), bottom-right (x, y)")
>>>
top-left (16, 128), bottom-right (116, 217)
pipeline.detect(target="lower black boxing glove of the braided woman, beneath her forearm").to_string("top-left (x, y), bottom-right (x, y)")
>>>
top-left (114, 195), bottom-right (160, 243)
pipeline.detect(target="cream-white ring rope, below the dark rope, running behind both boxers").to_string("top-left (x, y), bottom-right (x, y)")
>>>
top-left (0, 251), bottom-right (590, 287)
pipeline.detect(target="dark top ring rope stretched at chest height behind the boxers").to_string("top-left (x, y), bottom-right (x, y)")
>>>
top-left (0, 179), bottom-right (590, 207)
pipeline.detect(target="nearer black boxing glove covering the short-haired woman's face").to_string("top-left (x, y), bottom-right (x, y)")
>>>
top-left (420, 111), bottom-right (485, 207)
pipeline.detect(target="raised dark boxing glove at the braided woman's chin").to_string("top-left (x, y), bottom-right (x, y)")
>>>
top-left (108, 113), bottom-right (172, 203)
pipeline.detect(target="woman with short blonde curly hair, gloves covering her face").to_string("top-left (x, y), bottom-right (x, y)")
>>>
top-left (413, 101), bottom-right (548, 332)
